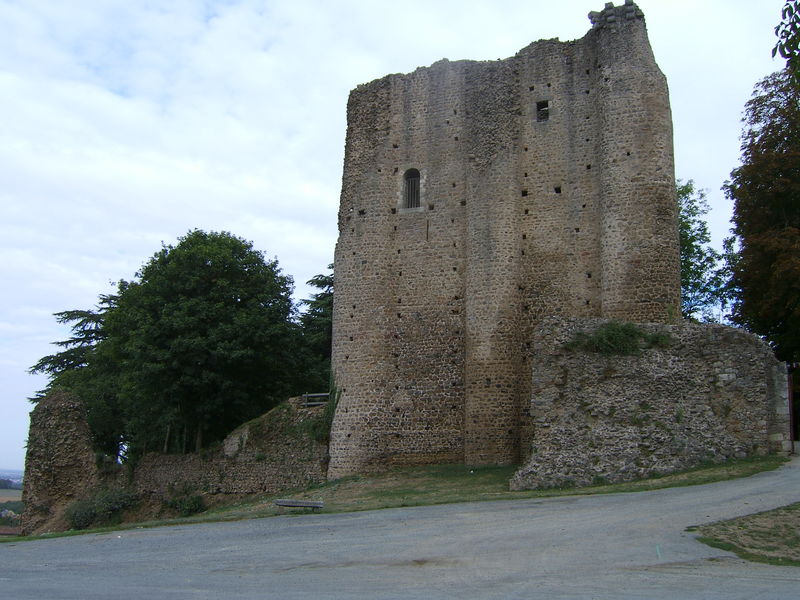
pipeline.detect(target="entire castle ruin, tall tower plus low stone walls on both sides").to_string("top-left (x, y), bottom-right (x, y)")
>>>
top-left (23, 0), bottom-right (793, 533)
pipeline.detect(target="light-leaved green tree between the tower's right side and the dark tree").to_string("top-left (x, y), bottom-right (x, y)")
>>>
top-left (676, 179), bottom-right (725, 321)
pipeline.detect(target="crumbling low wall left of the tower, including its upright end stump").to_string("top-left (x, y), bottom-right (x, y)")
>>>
top-left (22, 393), bottom-right (327, 535)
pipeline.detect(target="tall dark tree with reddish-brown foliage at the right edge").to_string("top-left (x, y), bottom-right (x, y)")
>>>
top-left (723, 70), bottom-right (800, 362)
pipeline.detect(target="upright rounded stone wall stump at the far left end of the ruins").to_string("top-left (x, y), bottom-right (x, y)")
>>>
top-left (22, 392), bottom-right (99, 535)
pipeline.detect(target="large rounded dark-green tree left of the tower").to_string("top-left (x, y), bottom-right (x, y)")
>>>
top-left (33, 230), bottom-right (303, 455)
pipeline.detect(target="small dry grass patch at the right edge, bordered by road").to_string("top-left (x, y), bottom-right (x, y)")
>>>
top-left (690, 502), bottom-right (800, 567)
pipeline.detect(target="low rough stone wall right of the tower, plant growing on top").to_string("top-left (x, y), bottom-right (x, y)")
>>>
top-left (511, 317), bottom-right (791, 489)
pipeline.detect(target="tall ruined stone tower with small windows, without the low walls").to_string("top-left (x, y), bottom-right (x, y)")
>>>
top-left (328, 0), bottom-right (680, 478)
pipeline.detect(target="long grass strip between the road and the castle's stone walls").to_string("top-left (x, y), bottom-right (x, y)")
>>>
top-left (0, 456), bottom-right (786, 542)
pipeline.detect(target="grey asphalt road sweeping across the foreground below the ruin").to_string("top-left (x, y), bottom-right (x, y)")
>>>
top-left (0, 458), bottom-right (800, 600)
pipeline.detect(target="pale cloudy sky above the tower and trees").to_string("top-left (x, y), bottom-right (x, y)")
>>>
top-left (0, 0), bottom-right (783, 469)
